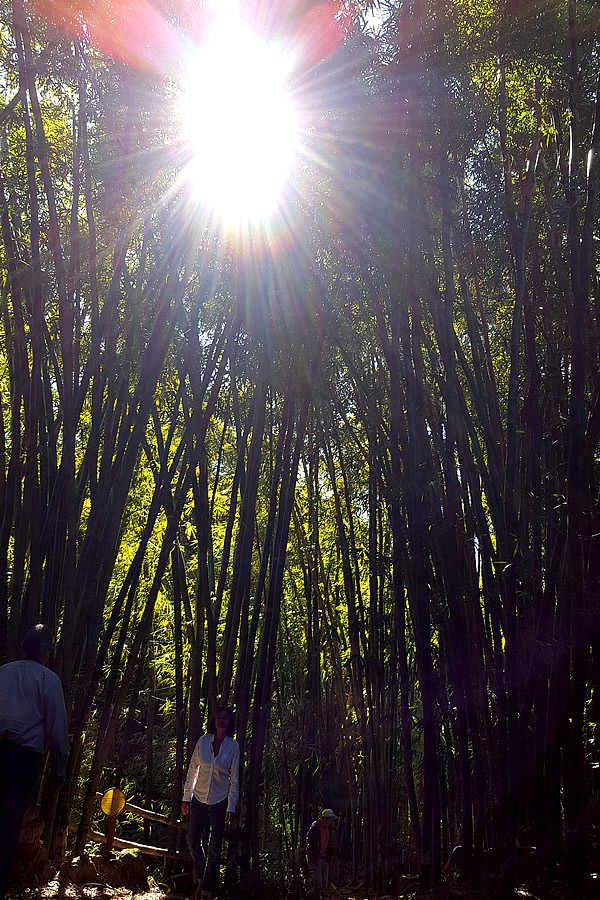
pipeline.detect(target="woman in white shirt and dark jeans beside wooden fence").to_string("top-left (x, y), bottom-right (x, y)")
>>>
top-left (181, 706), bottom-right (240, 900)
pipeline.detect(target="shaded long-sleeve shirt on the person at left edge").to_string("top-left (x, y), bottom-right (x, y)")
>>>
top-left (0, 659), bottom-right (69, 776)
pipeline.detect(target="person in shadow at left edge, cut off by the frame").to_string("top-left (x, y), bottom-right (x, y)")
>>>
top-left (0, 624), bottom-right (69, 898)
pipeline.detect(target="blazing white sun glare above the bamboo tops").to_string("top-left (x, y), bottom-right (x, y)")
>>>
top-left (182, 16), bottom-right (297, 224)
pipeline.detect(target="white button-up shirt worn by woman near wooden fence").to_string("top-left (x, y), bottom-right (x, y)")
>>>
top-left (183, 734), bottom-right (240, 812)
